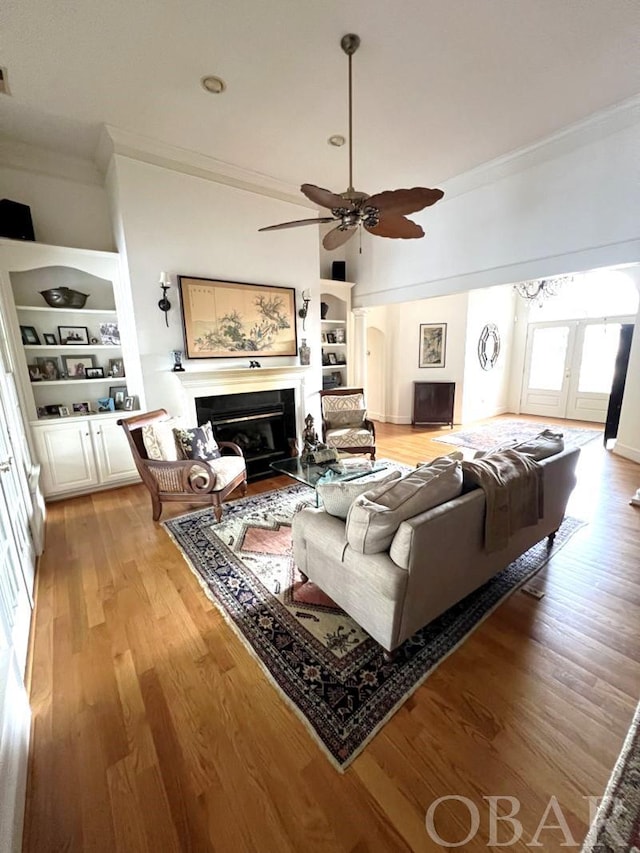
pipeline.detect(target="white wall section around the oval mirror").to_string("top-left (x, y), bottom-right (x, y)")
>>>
top-left (461, 285), bottom-right (515, 423)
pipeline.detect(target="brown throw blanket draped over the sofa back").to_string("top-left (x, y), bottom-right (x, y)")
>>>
top-left (462, 450), bottom-right (544, 553)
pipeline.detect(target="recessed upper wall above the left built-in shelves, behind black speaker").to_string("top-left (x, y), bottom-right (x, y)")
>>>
top-left (0, 143), bottom-right (115, 252)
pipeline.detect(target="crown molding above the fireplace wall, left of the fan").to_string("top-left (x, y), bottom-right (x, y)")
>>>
top-left (96, 125), bottom-right (317, 210)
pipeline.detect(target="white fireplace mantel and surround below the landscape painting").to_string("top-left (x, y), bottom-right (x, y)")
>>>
top-left (172, 365), bottom-right (309, 433)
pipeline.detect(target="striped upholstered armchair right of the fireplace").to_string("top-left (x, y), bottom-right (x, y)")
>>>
top-left (320, 388), bottom-right (376, 461)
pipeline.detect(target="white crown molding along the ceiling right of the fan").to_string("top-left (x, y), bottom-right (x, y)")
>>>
top-left (437, 95), bottom-right (640, 203)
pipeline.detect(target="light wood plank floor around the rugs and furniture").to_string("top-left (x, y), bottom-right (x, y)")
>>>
top-left (24, 412), bottom-right (640, 853)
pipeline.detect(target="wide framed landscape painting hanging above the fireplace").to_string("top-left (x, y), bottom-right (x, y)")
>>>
top-left (178, 276), bottom-right (298, 358)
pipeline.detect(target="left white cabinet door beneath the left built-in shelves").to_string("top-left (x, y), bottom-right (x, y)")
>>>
top-left (33, 420), bottom-right (98, 496)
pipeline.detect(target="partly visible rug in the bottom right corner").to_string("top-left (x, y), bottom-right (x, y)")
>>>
top-left (582, 705), bottom-right (640, 853)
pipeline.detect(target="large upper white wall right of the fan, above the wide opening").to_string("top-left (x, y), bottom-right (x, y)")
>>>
top-left (347, 110), bottom-right (640, 307)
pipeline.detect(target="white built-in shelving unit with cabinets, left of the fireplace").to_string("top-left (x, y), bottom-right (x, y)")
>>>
top-left (0, 240), bottom-right (143, 497)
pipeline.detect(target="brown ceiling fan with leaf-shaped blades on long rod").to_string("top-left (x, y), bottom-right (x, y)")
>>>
top-left (258, 33), bottom-right (444, 250)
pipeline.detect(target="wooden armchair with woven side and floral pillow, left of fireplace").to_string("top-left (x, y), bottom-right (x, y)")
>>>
top-left (118, 409), bottom-right (247, 521)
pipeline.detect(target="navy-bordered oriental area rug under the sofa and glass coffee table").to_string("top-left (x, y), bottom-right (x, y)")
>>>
top-left (163, 482), bottom-right (582, 771)
